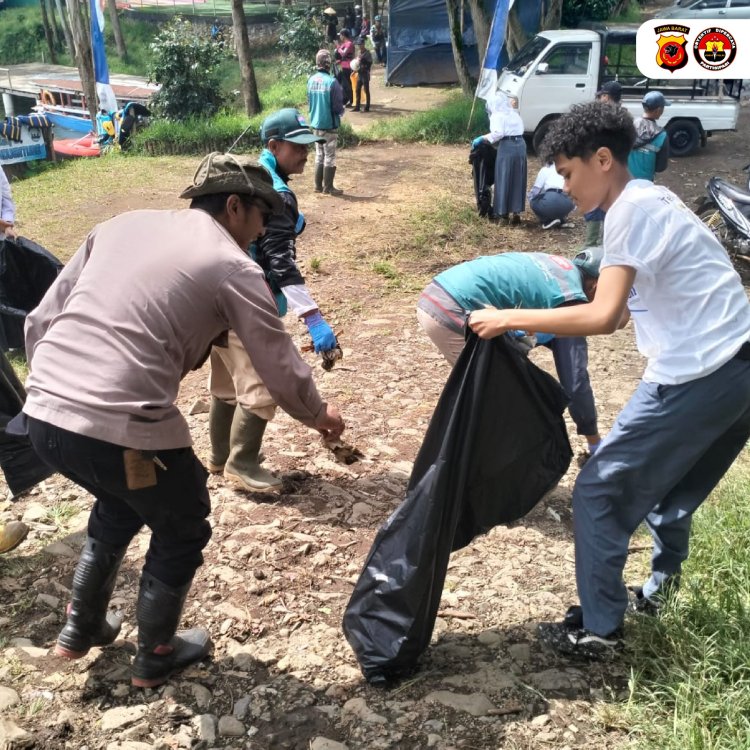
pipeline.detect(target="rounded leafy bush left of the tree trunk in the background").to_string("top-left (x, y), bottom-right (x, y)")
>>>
top-left (149, 18), bottom-right (224, 120)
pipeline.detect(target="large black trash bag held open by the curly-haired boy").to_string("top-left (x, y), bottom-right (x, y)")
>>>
top-left (343, 335), bottom-right (572, 684)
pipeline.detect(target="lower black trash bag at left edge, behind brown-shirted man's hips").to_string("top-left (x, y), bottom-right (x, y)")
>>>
top-left (0, 352), bottom-right (53, 495)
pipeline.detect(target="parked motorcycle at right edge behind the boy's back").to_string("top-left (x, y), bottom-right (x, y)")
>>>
top-left (696, 164), bottom-right (750, 260)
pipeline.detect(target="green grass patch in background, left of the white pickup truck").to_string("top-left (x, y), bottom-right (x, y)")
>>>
top-left (362, 93), bottom-right (489, 144)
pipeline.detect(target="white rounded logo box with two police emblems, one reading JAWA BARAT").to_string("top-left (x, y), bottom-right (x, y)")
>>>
top-left (635, 18), bottom-right (750, 80)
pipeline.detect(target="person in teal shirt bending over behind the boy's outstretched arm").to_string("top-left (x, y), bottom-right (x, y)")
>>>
top-left (417, 247), bottom-right (602, 454)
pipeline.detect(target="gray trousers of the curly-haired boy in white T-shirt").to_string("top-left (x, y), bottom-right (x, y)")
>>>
top-left (573, 358), bottom-right (750, 636)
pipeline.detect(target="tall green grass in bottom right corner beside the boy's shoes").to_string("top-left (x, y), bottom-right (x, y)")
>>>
top-left (610, 456), bottom-right (750, 750)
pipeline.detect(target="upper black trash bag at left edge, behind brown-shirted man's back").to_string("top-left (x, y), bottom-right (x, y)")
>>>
top-left (0, 237), bottom-right (62, 352)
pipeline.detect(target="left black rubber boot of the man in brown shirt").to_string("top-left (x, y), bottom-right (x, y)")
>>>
top-left (55, 537), bottom-right (128, 659)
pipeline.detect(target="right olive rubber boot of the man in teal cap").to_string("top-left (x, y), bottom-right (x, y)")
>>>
top-left (224, 405), bottom-right (283, 492)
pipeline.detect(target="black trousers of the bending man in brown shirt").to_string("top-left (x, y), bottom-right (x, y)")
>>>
top-left (29, 418), bottom-right (211, 587)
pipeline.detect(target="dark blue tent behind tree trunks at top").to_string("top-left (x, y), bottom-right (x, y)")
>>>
top-left (386, 0), bottom-right (545, 86)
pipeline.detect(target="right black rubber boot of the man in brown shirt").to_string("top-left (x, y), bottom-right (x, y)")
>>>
top-left (131, 572), bottom-right (211, 688)
